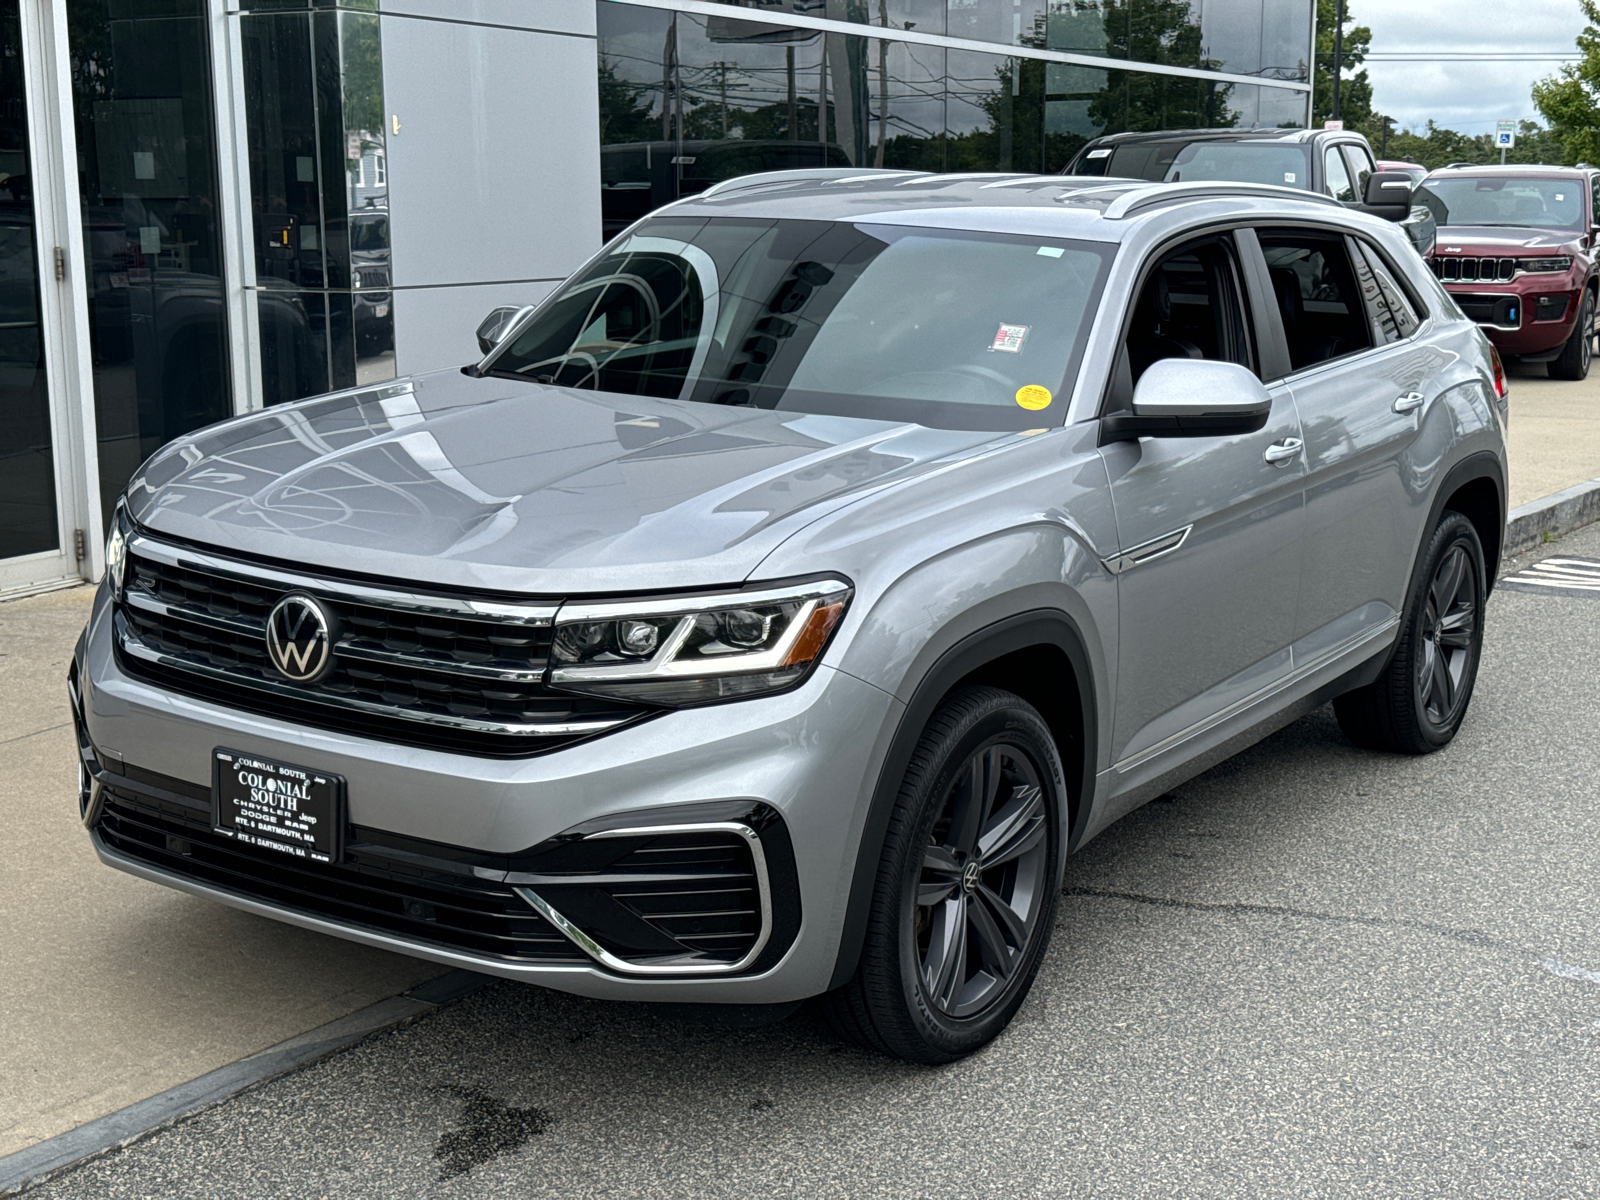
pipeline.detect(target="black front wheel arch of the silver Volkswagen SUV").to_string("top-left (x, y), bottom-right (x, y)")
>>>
top-left (829, 610), bottom-right (1099, 989)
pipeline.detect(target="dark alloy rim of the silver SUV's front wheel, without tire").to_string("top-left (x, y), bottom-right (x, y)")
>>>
top-left (907, 736), bottom-right (1050, 1018)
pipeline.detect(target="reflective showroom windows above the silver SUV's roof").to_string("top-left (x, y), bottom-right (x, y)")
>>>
top-left (597, 0), bottom-right (1306, 202)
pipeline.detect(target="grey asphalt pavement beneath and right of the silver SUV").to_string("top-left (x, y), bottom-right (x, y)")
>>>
top-left (21, 526), bottom-right (1600, 1200)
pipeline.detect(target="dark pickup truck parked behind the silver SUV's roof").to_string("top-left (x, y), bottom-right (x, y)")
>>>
top-left (1062, 130), bottom-right (1434, 258)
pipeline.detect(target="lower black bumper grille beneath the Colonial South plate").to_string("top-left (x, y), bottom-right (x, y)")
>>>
top-left (94, 773), bottom-right (587, 963)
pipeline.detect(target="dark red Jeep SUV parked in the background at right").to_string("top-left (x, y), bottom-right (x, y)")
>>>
top-left (1416, 166), bottom-right (1600, 379)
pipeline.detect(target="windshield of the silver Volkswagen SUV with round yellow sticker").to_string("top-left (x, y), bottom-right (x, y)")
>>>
top-left (486, 218), bottom-right (1114, 430)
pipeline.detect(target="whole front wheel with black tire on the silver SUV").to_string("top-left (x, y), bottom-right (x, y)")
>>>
top-left (821, 686), bottom-right (1066, 1064)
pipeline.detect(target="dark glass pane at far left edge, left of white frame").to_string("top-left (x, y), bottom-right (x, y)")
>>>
top-left (0, 0), bottom-right (59, 558)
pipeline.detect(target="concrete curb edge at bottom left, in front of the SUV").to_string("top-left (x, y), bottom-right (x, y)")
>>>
top-left (0, 971), bottom-right (494, 1195)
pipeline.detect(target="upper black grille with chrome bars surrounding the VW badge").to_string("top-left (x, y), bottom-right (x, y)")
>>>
top-left (115, 538), bottom-right (645, 757)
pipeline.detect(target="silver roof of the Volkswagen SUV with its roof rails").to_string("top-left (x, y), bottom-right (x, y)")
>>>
top-left (661, 168), bottom-right (1347, 242)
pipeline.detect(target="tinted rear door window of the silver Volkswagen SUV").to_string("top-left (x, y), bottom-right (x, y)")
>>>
top-left (1261, 229), bottom-right (1373, 371)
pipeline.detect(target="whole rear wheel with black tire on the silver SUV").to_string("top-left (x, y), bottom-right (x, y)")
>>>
top-left (1333, 512), bottom-right (1486, 754)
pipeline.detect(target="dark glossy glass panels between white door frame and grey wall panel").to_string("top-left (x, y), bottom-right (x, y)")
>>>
top-left (240, 5), bottom-right (395, 405)
